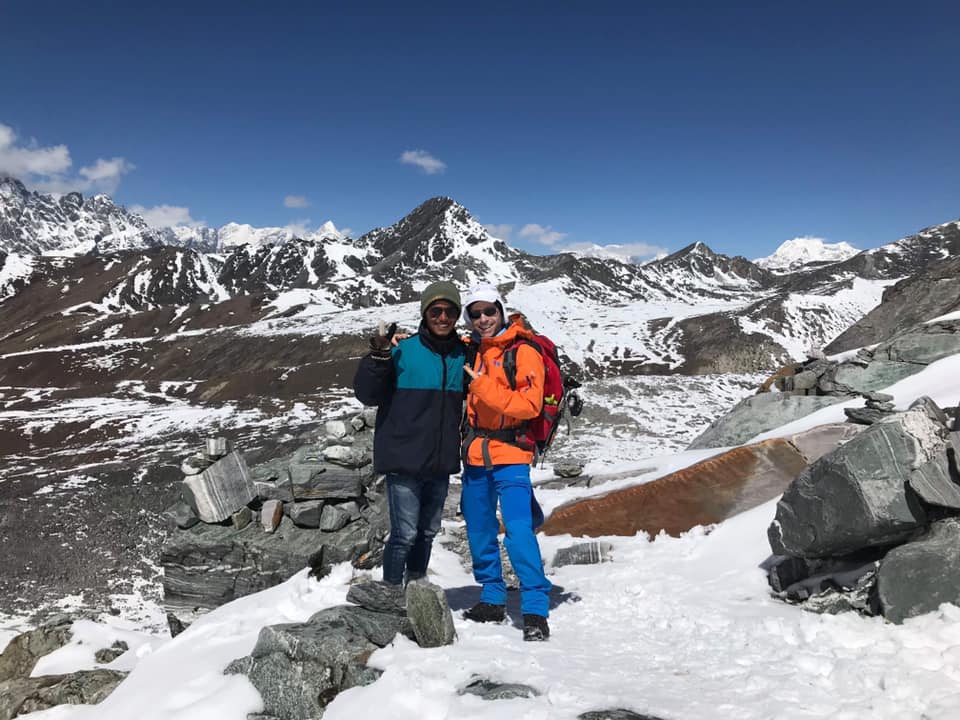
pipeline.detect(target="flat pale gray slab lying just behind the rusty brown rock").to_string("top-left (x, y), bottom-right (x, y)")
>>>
top-left (687, 393), bottom-right (843, 450)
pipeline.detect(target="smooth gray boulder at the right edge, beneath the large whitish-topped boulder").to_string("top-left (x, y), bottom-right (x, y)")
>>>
top-left (877, 518), bottom-right (960, 623)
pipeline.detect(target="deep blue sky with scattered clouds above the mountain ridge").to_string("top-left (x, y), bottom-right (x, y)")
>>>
top-left (0, 0), bottom-right (960, 257)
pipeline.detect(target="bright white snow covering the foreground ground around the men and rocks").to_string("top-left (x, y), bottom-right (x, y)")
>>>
top-left (13, 355), bottom-right (960, 720)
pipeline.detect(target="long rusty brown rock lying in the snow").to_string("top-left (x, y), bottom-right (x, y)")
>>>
top-left (541, 439), bottom-right (807, 537)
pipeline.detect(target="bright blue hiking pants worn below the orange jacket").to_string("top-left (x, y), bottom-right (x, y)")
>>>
top-left (461, 465), bottom-right (553, 617)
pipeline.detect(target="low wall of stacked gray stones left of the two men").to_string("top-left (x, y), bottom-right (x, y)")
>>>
top-left (161, 409), bottom-right (389, 634)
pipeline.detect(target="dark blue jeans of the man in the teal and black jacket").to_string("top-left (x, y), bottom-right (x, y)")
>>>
top-left (383, 474), bottom-right (450, 585)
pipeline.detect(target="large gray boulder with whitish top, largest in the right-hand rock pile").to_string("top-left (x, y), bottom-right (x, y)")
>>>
top-left (768, 410), bottom-right (942, 557)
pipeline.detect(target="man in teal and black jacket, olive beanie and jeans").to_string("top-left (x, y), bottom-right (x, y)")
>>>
top-left (353, 282), bottom-right (466, 586)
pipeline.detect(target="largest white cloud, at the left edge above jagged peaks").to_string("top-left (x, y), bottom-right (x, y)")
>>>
top-left (0, 124), bottom-right (134, 193)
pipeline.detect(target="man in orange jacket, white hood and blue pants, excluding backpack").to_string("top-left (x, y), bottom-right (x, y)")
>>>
top-left (461, 285), bottom-right (552, 641)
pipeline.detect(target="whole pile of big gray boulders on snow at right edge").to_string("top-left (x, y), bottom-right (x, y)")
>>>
top-left (763, 397), bottom-right (960, 623)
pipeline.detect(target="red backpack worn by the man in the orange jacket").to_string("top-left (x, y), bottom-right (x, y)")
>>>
top-left (503, 318), bottom-right (583, 465)
